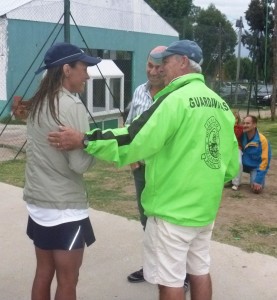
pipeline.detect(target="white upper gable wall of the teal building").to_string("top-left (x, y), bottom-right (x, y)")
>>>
top-left (1, 0), bottom-right (178, 36)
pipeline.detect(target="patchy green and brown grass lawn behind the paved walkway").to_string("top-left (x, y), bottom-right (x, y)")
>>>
top-left (0, 120), bottom-right (277, 257)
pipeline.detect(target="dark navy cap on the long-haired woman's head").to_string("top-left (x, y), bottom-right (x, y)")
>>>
top-left (35, 43), bottom-right (101, 74)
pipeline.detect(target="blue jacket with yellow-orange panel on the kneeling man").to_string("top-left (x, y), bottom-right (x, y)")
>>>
top-left (242, 130), bottom-right (271, 184)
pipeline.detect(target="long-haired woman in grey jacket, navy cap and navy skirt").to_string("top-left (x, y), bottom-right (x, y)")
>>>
top-left (23, 43), bottom-right (101, 300)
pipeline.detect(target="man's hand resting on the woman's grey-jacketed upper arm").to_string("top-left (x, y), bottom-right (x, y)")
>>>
top-left (48, 126), bottom-right (84, 150)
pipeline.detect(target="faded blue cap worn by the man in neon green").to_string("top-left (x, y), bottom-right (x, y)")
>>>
top-left (151, 40), bottom-right (203, 64)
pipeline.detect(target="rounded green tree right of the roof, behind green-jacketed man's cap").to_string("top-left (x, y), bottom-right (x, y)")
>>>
top-left (194, 4), bottom-right (237, 80)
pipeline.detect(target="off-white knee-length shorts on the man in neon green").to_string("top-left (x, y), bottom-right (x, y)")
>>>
top-left (143, 217), bottom-right (214, 287)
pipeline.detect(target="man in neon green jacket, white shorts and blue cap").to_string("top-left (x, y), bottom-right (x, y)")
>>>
top-left (48, 40), bottom-right (239, 300)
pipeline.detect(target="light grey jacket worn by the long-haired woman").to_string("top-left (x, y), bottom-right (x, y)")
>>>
top-left (23, 89), bottom-right (93, 209)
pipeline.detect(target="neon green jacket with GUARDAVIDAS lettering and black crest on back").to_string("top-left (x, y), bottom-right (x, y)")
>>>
top-left (86, 74), bottom-right (239, 226)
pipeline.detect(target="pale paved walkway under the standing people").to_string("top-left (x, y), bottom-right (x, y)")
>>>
top-left (0, 183), bottom-right (277, 300)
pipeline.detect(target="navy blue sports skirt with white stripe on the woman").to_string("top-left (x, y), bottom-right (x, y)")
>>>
top-left (27, 217), bottom-right (95, 250)
